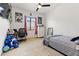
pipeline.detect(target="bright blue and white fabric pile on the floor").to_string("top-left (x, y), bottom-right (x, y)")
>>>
top-left (2, 35), bottom-right (19, 52)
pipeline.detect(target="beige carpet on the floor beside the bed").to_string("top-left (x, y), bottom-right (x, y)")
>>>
top-left (2, 38), bottom-right (63, 56)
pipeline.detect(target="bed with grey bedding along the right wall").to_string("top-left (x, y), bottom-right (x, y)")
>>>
top-left (43, 35), bottom-right (79, 56)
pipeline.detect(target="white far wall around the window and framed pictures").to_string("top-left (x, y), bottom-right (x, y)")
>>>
top-left (11, 6), bottom-right (45, 37)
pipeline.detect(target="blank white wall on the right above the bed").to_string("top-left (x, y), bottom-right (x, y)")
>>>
top-left (46, 3), bottom-right (79, 36)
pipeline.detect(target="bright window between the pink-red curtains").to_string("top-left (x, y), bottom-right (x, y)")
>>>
top-left (27, 17), bottom-right (35, 30)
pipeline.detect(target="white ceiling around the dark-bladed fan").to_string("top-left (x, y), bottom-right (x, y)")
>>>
top-left (12, 3), bottom-right (57, 14)
